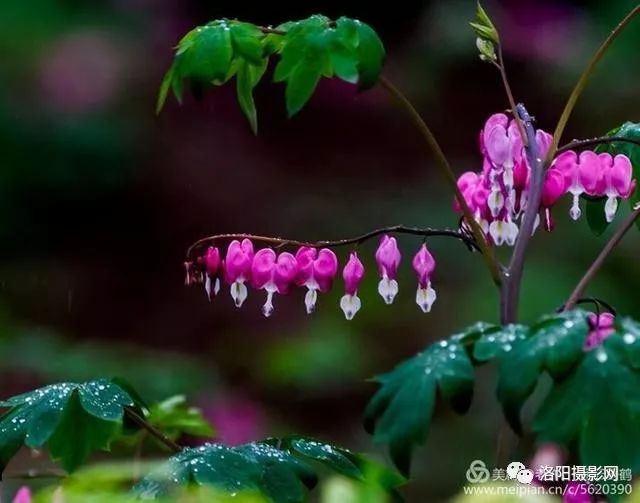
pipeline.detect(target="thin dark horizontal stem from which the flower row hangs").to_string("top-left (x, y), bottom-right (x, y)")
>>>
top-left (187, 225), bottom-right (480, 259)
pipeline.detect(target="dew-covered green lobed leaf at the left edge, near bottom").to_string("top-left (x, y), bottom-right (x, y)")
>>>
top-left (0, 379), bottom-right (139, 472)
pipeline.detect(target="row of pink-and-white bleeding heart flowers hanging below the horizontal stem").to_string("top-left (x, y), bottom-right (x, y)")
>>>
top-left (185, 235), bottom-right (436, 320)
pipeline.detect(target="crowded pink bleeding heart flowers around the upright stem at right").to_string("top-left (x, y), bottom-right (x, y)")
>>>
top-left (454, 113), bottom-right (636, 246)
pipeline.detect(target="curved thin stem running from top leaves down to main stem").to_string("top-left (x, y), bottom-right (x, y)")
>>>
top-left (379, 75), bottom-right (502, 286)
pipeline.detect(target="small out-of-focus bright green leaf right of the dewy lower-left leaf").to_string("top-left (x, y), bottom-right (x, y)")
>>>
top-left (147, 395), bottom-right (214, 440)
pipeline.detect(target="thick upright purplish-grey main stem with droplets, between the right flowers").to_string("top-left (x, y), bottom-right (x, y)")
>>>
top-left (500, 104), bottom-right (544, 323)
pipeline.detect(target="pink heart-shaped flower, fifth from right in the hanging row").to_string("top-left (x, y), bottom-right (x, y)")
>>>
top-left (251, 248), bottom-right (298, 318)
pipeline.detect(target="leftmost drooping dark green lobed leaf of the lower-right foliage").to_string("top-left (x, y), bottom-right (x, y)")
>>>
top-left (364, 324), bottom-right (478, 475)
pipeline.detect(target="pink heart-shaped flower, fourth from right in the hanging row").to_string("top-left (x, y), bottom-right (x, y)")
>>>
top-left (296, 246), bottom-right (338, 314)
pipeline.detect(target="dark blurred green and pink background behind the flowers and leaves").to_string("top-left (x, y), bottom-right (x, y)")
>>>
top-left (0, 0), bottom-right (640, 501)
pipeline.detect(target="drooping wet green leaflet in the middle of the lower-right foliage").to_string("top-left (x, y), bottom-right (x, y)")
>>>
top-left (497, 309), bottom-right (588, 433)
